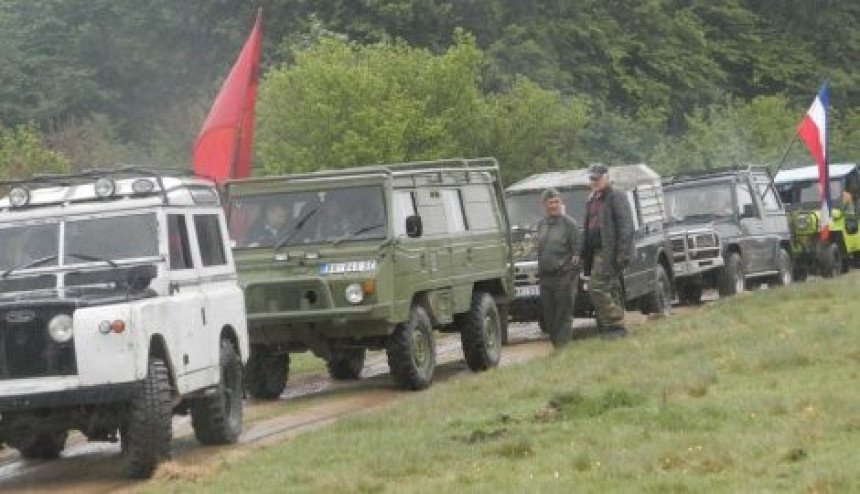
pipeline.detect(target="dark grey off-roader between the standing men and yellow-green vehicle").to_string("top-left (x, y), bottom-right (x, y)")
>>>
top-left (664, 167), bottom-right (793, 302)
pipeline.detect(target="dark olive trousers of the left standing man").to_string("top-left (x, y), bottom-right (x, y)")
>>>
top-left (540, 270), bottom-right (578, 347)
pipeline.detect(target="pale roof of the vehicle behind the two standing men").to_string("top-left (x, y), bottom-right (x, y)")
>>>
top-left (505, 163), bottom-right (660, 194)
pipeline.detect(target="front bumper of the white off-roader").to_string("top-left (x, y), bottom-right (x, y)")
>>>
top-left (0, 376), bottom-right (138, 413)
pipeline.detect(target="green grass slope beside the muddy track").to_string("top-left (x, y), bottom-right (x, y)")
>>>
top-left (152, 275), bottom-right (860, 493)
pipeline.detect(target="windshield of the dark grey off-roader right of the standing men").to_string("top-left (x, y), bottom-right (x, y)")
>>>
top-left (664, 182), bottom-right (735, 221)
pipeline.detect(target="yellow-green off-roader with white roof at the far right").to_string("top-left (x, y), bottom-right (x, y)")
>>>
top-left (774, 163), bottom-right (860, 280)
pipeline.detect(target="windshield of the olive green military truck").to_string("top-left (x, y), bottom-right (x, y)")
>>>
top-left (230, 185), bottom-right (386, 248)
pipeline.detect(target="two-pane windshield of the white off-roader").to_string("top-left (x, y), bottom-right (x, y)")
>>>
top-left (0, 213), bottom-right (158, 272)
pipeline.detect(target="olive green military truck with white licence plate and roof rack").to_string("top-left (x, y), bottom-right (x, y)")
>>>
top-left (226, 158), bottom-right (513, 399)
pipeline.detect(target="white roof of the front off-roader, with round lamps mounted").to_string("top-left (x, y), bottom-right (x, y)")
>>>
top-left (0, 167), bottom-right (220, 216)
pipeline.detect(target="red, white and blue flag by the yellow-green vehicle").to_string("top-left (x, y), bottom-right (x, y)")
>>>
top-left (797, 82), bottom-right (830, 240)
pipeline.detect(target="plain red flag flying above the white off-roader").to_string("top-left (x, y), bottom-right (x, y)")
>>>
top-left (193, 9), bottom-right (263, 182)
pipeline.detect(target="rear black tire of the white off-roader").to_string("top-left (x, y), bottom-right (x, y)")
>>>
top-left (191, 340), bottom-right (244, 445)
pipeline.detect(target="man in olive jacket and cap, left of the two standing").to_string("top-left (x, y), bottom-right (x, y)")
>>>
top-left (537, 189), bottom-right (581, 347)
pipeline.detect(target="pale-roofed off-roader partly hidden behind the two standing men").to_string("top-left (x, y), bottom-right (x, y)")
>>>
top-left (505, 164), bottom-right (673, 322)
